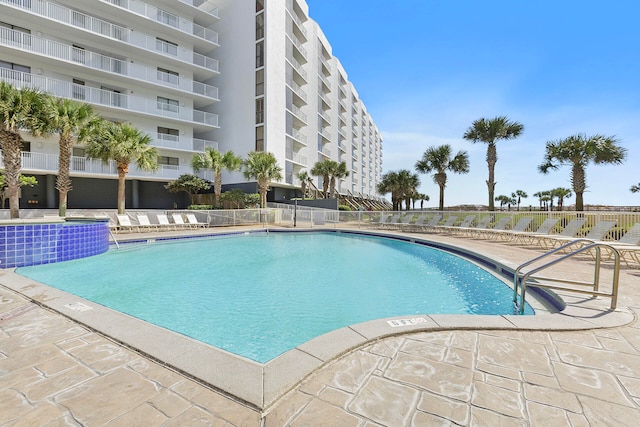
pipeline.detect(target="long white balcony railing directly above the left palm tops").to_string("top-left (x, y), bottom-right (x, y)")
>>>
top-left (0, 68), bottom-right (218, 127)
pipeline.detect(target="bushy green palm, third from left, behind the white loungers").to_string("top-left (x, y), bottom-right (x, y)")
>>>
top-left (87, 121), bottom-right (159, 215)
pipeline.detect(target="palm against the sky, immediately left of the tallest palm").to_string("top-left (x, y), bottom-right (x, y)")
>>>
top-left (416, 144), bottom-right (469, 210)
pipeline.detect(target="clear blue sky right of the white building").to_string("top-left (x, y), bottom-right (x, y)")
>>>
top-left (307, 0), bottom-right (640, 206)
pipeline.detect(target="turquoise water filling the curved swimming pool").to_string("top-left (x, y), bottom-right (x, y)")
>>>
top-left (18, 232), bottom-right (533, 362)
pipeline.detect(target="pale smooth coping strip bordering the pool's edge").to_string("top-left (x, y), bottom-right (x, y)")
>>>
top-left (0, 228), bottom-right (635, 412)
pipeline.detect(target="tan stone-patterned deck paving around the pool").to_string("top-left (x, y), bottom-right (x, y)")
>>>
top-left (0, 228), bottom-right (640, 426)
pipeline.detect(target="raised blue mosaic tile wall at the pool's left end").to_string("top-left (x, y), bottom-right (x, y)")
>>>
top-left (0, 221), bottom-right (109, 268)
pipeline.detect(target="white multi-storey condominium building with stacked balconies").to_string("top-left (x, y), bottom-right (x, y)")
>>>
top-left (0, 0), bottom-right (382, 209)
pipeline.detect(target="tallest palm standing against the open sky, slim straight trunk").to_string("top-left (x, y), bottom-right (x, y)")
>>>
top-left (463, 116), bottom-right (524, 211)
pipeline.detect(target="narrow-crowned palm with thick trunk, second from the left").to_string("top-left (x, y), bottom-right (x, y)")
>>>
top-left (47, 97), bottom-right (95, 216)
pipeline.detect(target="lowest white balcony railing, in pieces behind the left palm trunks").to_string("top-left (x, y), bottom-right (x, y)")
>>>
top-left (5, 152), bottom-right (193, 179)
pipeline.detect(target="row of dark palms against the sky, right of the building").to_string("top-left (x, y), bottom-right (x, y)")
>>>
top-left (378, 116), bottom-right (628, 211)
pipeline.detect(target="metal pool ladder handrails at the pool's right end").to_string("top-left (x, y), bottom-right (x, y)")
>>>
top-left (513, 239), bottom-right (620, 314)
